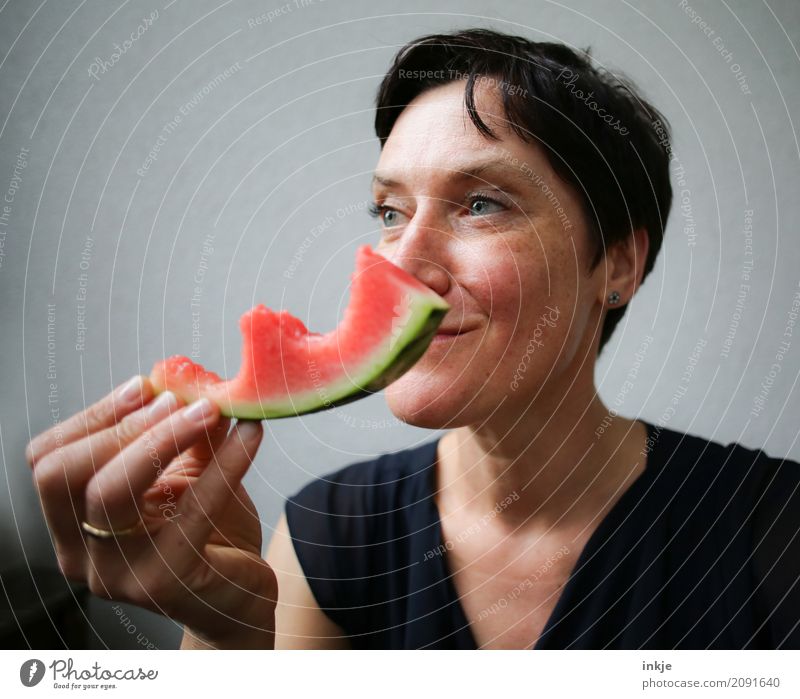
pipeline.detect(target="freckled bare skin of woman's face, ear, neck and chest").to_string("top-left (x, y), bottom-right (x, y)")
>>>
top-left (373, 82), bottom-right (647, 648)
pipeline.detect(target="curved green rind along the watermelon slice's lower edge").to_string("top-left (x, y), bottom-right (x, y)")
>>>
top-left (209, 293), bottom-right (450, 420)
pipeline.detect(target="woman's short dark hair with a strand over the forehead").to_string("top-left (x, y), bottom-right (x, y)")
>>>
top-left (375, 29), bottom-right (672, 349)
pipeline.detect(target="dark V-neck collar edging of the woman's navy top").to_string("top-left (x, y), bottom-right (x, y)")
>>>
top-left (425, 418), bottom-right (664, 650)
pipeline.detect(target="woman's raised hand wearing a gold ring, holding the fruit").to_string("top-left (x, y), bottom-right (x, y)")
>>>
top-left (26, 377), bottom-right (277, 648)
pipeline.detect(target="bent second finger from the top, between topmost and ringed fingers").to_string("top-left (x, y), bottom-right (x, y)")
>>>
top-left (34, 392), bottom-right (181, 567)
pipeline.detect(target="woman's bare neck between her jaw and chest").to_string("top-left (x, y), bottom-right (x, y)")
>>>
top-left (437, 382), bottom-right (646, 530)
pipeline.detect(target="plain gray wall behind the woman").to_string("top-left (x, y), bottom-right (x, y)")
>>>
top-left (0, 0), bottom-right (800, 648)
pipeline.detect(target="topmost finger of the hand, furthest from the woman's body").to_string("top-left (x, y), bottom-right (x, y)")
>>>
top-left (25, 376), bottom-right (154, 467)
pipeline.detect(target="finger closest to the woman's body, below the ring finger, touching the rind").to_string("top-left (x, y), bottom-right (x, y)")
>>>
top-left (158, 420), bottom-right (264, 567)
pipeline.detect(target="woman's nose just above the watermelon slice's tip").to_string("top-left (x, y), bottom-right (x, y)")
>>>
top-left (382, 205), bottom-right (452, 296)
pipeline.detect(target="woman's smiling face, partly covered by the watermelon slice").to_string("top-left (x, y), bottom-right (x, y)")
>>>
top-left (373, 76), bottom-right (605, 428)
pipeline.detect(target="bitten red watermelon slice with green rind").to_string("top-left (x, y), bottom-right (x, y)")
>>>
top-left (150, 245), bottom-right (450, 420)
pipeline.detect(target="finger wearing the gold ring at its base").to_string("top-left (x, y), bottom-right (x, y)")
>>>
top-left (86, 398), bottom-right (220, 529)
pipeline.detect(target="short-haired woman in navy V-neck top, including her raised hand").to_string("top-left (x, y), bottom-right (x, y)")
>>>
top-left (28, 30), bottom-right (800, 648)
